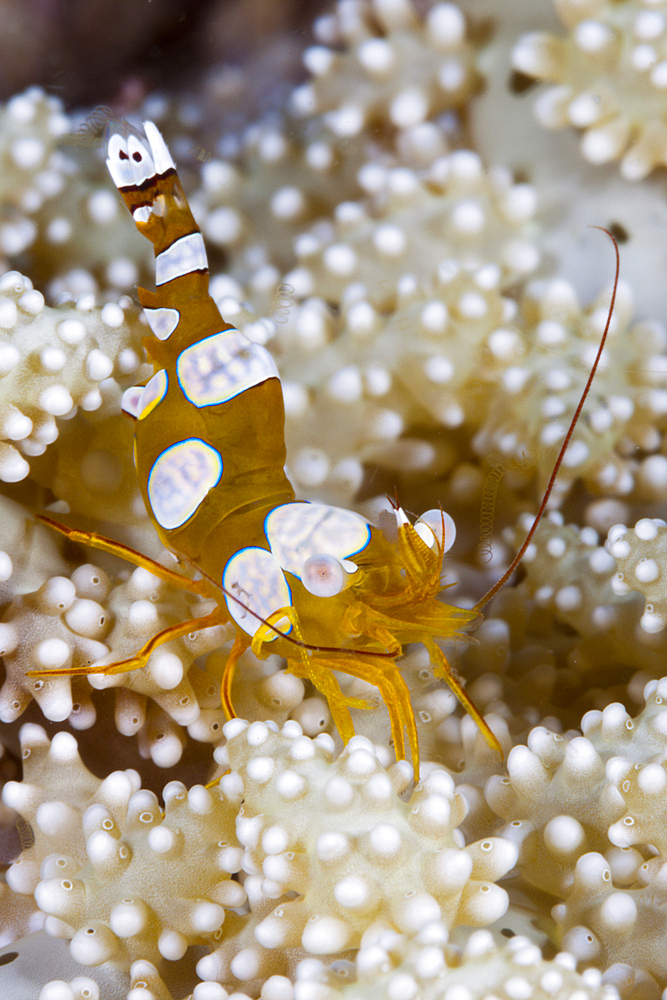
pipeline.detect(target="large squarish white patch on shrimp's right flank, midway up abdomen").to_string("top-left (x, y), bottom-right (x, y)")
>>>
top-left (176, 330), bottom-right (279, 407)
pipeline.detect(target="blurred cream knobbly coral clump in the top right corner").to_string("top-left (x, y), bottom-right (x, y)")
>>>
top-left (512, 0), bottom-right (667, 181)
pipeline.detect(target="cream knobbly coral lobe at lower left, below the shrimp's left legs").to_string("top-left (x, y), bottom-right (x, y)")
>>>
top-left (4, 726), bottom-right (246, 966)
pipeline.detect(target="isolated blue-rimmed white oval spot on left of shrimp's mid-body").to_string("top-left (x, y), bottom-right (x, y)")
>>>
top-left (148, 438), bottom-right (222, 530)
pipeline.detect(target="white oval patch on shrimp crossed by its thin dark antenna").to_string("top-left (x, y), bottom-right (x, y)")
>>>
top-left (222, 547), bottom-right (292, 642)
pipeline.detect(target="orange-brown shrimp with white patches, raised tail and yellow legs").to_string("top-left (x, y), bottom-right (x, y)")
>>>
top-left (32, 122), bottom-right (499, 770)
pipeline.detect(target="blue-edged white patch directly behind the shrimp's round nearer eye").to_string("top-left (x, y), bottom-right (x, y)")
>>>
top-left (264, 503), bottom-right (371, 579)
